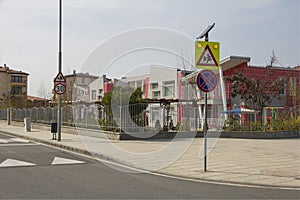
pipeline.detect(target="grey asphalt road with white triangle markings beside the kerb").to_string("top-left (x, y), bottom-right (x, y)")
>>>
top-left (0, 134), bottom-right (300, 199)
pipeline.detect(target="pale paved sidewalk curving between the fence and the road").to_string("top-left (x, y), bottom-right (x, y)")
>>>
top-left (0, 121), bottom-right (300, 189)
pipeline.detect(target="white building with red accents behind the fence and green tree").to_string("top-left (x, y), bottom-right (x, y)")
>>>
top-left (89, 66), bottom-right (227, 129)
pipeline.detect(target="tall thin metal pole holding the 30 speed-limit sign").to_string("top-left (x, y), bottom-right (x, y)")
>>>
top-left (57, 0), bottom-right (62, 141)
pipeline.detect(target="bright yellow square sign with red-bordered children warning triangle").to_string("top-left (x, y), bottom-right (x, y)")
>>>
top-left (195, 41), bottom-right (220, 69)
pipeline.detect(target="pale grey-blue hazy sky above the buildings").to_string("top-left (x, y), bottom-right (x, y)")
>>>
top-left (0, 0), bottom-right (300, 95)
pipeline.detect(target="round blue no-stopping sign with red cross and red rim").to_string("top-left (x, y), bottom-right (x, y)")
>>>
top-left (197, 69), bottom-right (217, 92)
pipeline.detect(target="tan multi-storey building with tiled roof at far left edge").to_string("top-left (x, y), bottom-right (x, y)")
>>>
top-left (0, 64), bottom-right (29, 107)
